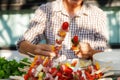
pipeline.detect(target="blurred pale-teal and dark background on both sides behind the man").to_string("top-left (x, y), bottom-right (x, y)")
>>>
top-left (0, 0), bottom-right (120, 49)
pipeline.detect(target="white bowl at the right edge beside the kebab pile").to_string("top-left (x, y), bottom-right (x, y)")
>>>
top-left (93, 50), bottom-right (120, 71)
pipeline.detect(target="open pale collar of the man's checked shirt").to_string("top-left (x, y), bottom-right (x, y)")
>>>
top-left (53, 0), bottom-right (88, 16)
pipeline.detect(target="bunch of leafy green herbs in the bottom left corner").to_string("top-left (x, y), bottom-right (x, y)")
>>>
top-left (0, 57), bottom-right (29, 79)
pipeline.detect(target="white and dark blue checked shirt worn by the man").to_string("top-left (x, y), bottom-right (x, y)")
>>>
top-left (18, 0), bottom-right (108, 58)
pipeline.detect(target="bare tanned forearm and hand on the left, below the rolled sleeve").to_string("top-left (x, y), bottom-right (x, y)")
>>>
top-left (19, 41), bottom-right (56, 57)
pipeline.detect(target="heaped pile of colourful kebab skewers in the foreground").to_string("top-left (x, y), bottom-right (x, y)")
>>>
top-left (23, 55), bottom-right (113, 80)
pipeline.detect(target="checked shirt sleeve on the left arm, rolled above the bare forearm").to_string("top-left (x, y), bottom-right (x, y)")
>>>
top-left (17, 7), bottom-right (46, 48)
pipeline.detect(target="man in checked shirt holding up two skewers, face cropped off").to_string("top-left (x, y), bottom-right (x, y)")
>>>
top-left (18, 0), bottom-right (108, 59)
